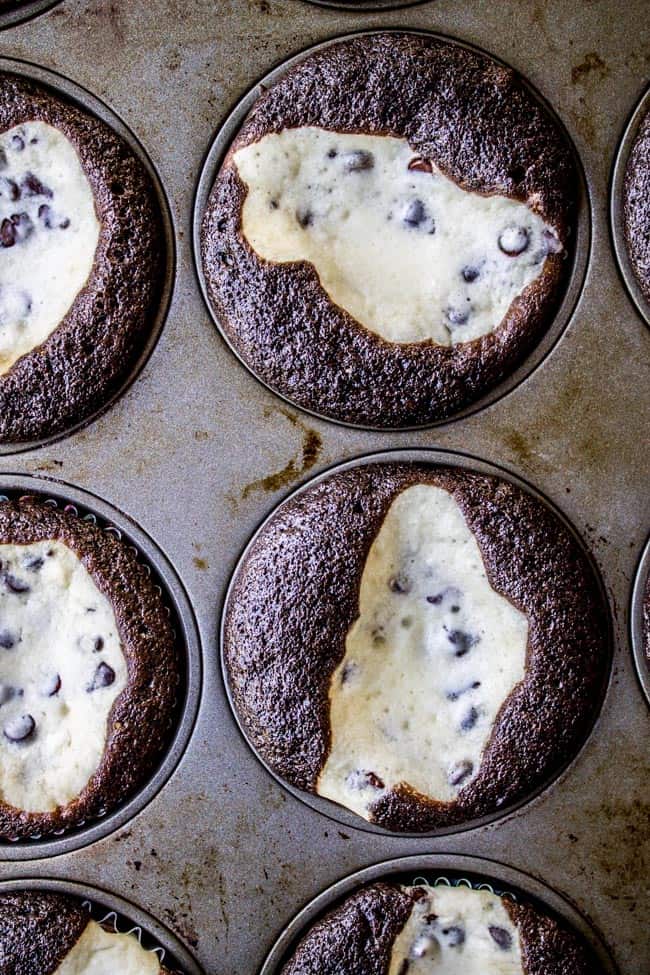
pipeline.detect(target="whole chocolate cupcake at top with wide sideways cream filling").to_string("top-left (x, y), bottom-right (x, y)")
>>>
top-left (201, 33), bottom-right (578, 427)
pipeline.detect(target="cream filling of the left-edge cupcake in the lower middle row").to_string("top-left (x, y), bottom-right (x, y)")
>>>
top-left (0, 541), bottom-right (127, 812)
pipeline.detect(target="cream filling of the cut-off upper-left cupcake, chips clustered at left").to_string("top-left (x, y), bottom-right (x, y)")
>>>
top-left (0, 115), bottom-right (100, 375)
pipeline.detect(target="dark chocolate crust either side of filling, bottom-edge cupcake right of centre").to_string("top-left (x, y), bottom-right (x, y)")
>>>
top-left (282, 883), bottom-right (601, 975)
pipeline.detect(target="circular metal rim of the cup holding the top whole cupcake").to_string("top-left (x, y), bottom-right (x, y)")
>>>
top-left (193, 30), bottom-right (591, 433)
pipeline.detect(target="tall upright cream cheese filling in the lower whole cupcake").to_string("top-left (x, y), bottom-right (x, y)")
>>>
top-left (317, 484), bottom-right (528, 819)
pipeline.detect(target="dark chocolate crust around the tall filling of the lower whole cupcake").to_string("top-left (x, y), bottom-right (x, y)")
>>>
top-left (224, 462), bottom-right (609, 831)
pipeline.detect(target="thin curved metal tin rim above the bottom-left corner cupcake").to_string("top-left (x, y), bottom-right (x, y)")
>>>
top-left (0, 877), bottom-right (203, 975)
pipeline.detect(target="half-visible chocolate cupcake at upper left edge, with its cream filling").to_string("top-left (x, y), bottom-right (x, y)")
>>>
top-left (0, 73), bottom-right (165, 443)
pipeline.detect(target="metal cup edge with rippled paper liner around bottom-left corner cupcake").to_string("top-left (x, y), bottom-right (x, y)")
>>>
top-left (0, 877), bottom-right (202, 975)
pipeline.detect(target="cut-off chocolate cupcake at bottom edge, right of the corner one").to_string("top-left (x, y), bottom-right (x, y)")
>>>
top-left (282, 883), bottom-right (601, 975)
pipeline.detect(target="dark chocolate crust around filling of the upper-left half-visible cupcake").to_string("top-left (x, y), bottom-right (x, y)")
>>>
top-left (0, 73), bottom-right (165, 442)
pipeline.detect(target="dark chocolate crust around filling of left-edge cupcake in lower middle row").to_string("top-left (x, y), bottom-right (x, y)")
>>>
top-left (0, 499), bottom-right (180, 839)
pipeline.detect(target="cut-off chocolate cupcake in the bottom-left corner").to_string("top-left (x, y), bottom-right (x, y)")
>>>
top-left (0, 890), bottom-right (169, 975)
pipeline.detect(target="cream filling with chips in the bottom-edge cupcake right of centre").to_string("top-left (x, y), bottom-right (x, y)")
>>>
top-left (388, 885), bottom-right (524, 975)
